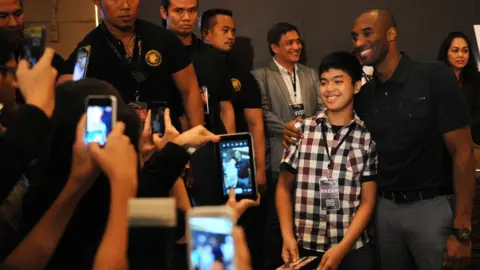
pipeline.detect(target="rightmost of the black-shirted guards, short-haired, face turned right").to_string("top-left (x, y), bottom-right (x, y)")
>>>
top-left (200, 9), bottom-right (266, 269)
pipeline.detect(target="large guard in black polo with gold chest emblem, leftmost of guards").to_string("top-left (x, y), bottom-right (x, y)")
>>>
top-left (61, 0), bottom-right (203, 130)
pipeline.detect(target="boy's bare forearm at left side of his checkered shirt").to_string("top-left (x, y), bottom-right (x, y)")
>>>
top-left (275, 180), bottom-right (294, 238)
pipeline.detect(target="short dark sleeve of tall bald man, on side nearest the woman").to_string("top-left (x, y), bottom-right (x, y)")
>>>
top-left (431, 65), bottom-right (470, 134)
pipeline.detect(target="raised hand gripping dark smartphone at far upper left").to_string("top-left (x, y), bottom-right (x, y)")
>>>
top-left (15, 48), bottom-right (57, 117)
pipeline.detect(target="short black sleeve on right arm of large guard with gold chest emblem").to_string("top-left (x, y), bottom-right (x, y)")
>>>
top-left (163, 31), bottom-right (192, 74)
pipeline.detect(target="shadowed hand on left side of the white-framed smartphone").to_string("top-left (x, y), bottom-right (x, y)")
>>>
top-left (69, 114), bottom-right (99, 189)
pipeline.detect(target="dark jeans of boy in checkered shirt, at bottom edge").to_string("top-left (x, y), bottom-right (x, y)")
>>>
top-left (298, 243), bottom-right (375, 270)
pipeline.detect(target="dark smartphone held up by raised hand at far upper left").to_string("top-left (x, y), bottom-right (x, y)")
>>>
top-left (20, 26), bottom-right (46, 67)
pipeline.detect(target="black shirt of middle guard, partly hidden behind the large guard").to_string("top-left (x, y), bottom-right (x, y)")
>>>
top-left (193, 43), bottom-right (235, 134)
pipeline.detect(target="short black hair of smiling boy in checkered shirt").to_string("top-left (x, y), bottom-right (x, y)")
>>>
top-left (318, 51), bottom-right (362, 83)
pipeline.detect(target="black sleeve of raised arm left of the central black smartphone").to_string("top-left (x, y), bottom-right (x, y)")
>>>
top-left (138, 143), bottom-right (190, 197)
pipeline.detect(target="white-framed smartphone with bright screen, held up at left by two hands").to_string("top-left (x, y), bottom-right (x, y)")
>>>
top-left (85, 95), bottom-right (117, 146)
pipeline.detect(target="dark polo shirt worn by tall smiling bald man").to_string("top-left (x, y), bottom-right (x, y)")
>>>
top-left (355, 54), bottom-right (469, 191)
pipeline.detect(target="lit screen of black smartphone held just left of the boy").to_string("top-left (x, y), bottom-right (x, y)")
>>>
top-left (218, 138), bottom-right (256, 196)
